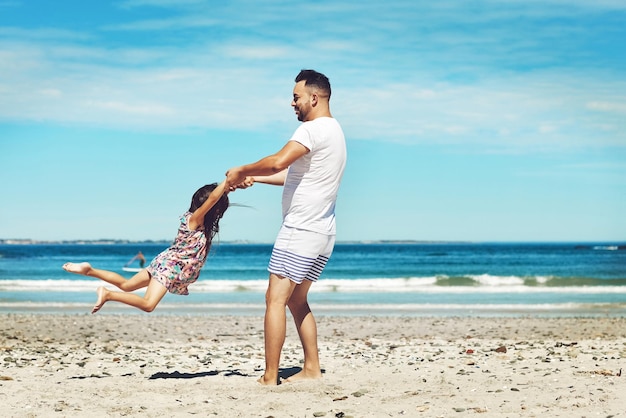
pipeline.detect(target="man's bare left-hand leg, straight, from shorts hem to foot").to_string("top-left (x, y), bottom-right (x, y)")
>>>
top-left (259, 273), bottom-right (296, 385)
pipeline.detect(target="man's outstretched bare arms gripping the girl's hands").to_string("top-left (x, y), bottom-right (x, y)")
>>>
top-left (226, 141), bottom-right (309, 185)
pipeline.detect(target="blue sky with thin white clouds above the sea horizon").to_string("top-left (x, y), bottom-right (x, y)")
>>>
top-left (0, 0), bottom-right (626, 242)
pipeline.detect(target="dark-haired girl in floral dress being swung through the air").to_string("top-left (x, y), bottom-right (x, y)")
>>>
top-left (63, 181), bottom-right (228, 314)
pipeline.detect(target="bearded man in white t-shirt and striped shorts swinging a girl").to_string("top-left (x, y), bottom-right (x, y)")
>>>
top-left (226, 70), bottom-right (346, 385)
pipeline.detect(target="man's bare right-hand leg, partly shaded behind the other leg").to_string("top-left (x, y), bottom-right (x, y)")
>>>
top-left (287, 280), bottom-right (322, 382)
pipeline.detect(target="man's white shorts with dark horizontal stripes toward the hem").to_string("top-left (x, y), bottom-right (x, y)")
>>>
top-left (267, 225), bottom-right (335, 284)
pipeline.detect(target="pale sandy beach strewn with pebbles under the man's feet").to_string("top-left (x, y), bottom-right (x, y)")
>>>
top-left (0, 314), bottom-right (626, 418)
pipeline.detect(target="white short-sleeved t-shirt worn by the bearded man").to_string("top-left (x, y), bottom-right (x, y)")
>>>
top-left (283, 117), bottom-right (346, 235)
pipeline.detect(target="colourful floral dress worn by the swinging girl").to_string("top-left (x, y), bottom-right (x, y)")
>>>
top-left (146, 212), bottom-right (208, 295)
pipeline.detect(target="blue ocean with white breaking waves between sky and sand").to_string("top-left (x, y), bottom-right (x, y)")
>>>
top-left (0, 242), bottom-right (626, 316)
